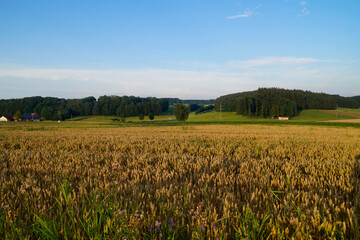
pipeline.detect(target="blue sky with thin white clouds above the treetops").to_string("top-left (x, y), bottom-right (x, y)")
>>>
top-left (0, 0), bottom-right (360, 99)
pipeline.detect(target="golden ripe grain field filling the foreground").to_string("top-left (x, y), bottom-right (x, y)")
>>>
top-left (0, 125), bottom-right (360, 239)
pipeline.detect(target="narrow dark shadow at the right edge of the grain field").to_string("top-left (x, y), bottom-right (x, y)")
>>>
top-left (352, 154), bottom-right (360, 239)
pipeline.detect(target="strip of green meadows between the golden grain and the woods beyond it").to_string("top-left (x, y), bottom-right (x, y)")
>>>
top-left (0, 108), bottom-right (360, 130)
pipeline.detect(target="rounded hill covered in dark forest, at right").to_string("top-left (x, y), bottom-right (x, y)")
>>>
top-left (215, 88), bottom-right (360, 118)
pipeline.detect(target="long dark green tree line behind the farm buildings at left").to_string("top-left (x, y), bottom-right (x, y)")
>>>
top-left (0, 95), bottom-right (169, 120)
